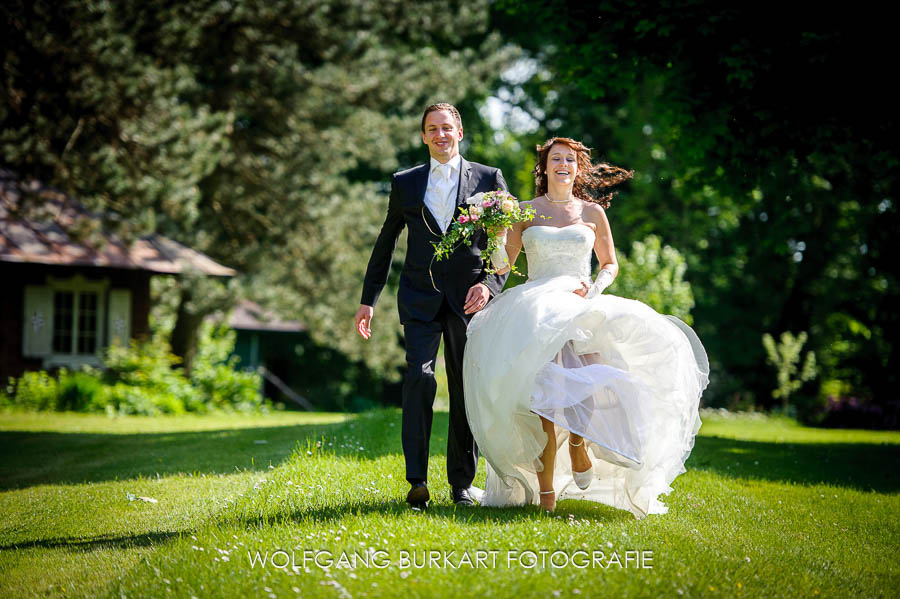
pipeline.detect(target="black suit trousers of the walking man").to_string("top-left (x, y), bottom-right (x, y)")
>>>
top-left (401, 299), bottom-right (478, 487)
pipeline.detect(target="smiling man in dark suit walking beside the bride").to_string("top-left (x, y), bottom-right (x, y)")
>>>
top-left (356, 104), bottom-right (506, 508)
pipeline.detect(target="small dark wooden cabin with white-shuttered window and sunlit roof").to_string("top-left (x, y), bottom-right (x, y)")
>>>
top-left (0, 170), bottom-right (236, 383)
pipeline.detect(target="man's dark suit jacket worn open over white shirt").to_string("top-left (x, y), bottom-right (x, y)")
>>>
top-left (361, 158), bottom-right (507, 323)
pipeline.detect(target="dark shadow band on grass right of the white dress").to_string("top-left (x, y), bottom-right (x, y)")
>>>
top-left (685, 437), bottom-right (900, 493)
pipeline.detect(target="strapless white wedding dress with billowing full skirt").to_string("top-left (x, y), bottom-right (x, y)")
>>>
top-left (463, 224), bottom-right (709, 518)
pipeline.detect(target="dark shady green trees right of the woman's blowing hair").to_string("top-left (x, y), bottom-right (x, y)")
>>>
top-left (497, 0), bottom-right (900, 412)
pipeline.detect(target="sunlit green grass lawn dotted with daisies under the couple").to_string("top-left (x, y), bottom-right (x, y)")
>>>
top-left (0, 410), bottom-right (900, 598)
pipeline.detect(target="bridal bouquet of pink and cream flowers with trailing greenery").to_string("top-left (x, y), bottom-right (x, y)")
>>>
top-left (431, 189), bottom-right (534, 274)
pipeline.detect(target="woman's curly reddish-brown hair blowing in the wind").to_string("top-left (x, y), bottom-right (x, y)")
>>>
top-left (531, 137), bottom-right (634, 208)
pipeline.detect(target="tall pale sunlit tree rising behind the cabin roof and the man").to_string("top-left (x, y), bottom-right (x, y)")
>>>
top-left (0, 0), bottom-right (514, 384)
